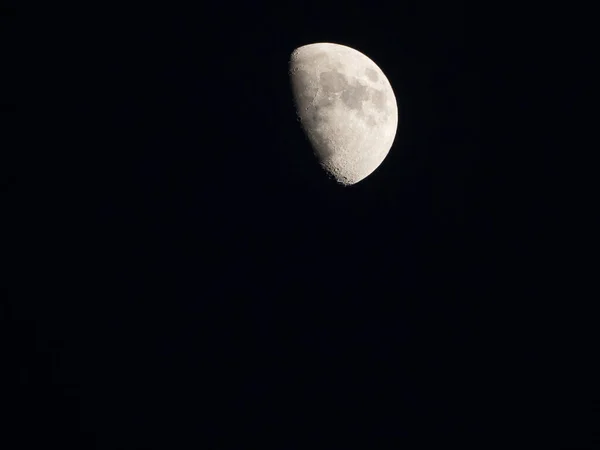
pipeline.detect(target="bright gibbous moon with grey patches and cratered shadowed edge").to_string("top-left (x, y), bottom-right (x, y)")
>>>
top-left (289, 42), bottom-right (398, 186)
